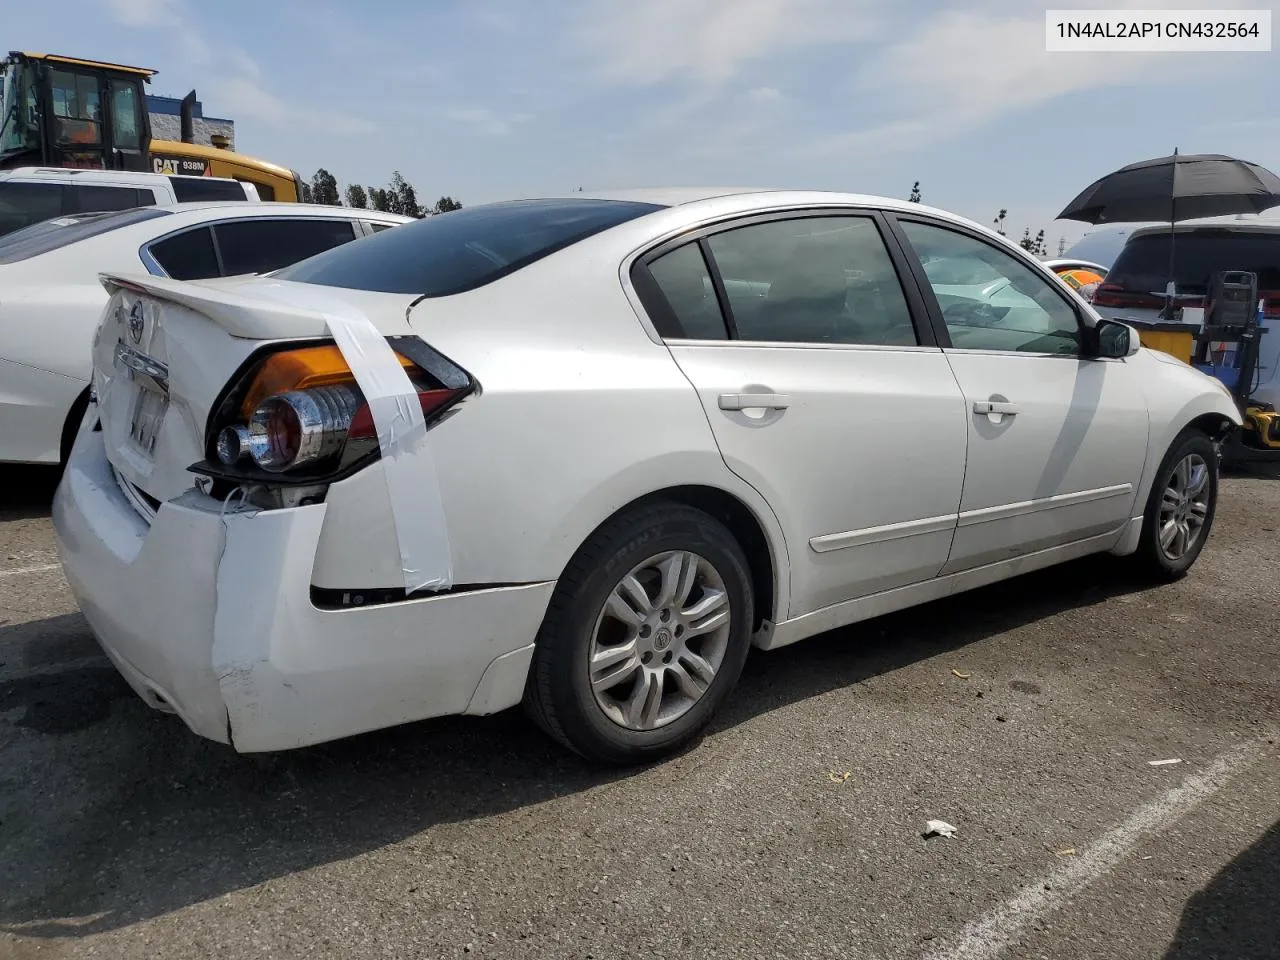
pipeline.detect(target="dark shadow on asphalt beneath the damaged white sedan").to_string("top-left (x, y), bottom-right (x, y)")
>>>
top-left (0, 557), bottom-right (1157, 937)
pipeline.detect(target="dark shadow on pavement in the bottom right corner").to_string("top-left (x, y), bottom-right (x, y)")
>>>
top-left (1165, 822), bottom-right (1280, 960)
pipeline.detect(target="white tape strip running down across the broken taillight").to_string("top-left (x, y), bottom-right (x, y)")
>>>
top-left (255, 284), bottom-right (453, 594)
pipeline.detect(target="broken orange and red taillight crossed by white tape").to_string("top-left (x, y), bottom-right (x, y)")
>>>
top-left (202, 338), bottom-right (475, 483)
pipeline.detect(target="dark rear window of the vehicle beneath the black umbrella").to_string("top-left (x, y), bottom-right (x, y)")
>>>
top-left (1107, 230), bottom-right (1280, 294)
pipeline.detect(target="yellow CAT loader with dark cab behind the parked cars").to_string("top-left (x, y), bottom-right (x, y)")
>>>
top-left (0, 51), bottom-right (302, 202)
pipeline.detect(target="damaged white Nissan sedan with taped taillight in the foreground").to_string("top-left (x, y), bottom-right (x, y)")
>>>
top-left (54, 192), bottom-right (1240, 763)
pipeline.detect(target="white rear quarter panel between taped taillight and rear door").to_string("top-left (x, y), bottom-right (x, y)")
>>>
top-left (314, 255), bottom-right (786, 609)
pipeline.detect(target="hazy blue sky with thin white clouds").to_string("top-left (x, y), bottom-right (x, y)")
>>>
top-left (10, 0), bottom-right (1280, 248)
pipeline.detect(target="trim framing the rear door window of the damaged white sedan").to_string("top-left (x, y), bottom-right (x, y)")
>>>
top-left (623, 205), bottom-right (942, 351)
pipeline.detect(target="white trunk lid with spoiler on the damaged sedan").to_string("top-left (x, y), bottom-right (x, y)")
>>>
top-left (93, 275), bottom-right (424, 506)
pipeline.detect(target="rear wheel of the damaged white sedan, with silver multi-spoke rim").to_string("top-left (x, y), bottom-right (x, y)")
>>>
top-left (525, 503), bottom-right (753, 764)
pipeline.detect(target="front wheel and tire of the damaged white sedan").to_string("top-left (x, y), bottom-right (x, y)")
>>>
top-left (1133, 428), bottom-right (1217, 582)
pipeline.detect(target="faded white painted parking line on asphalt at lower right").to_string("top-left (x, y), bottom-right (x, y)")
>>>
top-left (925, 740), bottom-right (1265, 960)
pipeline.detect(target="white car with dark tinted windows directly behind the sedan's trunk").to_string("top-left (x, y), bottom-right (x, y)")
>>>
top-left (0, 204), bottom-right (408, 463)
